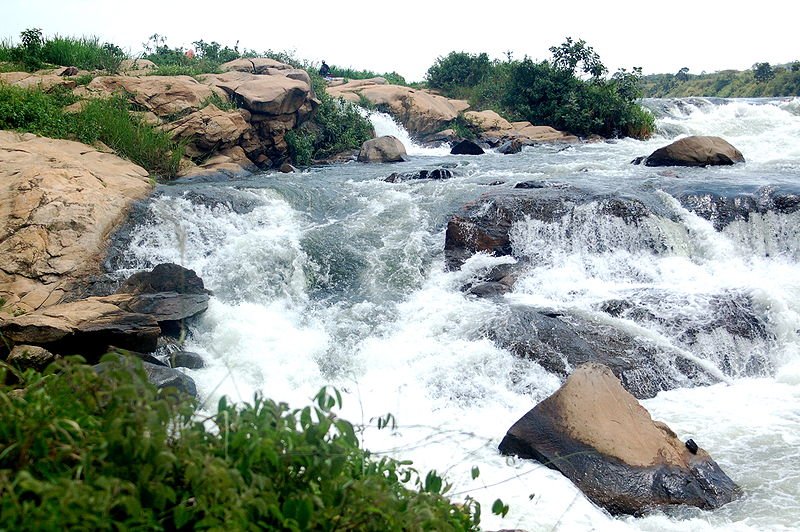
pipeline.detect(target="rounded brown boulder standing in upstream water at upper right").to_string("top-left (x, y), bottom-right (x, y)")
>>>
top-left (644, 136), bottom-right (744, 166)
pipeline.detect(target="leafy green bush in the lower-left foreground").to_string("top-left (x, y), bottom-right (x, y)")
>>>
top-left (0, 356), bottom-right (480, 531)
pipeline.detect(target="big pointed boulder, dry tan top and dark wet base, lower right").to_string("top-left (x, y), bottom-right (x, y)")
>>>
top-left (499, 364), bottom-right (741, 515)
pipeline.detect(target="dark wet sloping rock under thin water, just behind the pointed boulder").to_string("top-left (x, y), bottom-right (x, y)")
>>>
top-left (484, 306), bottom-right (717, 399)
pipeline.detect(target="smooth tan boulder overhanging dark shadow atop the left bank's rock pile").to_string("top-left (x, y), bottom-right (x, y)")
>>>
top-left (201, 71), bottom-right (311, 116)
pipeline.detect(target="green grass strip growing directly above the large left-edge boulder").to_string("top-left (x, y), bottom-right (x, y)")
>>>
top-left (0, 84), bottom-right (183, 178)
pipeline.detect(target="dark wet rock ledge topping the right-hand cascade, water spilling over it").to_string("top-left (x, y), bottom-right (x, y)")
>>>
top-left (444, 187), bottom-right (649, 269)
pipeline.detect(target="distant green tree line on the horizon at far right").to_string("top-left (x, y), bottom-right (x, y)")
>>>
top-left (641, 61), bottom-right (800, 98)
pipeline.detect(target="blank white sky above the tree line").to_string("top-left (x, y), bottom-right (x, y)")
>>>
top-left (0, 0), bottom-right (800, 81)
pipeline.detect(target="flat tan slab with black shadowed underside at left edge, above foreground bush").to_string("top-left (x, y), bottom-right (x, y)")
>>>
top-left (0, 297), bottom-right (161, 358)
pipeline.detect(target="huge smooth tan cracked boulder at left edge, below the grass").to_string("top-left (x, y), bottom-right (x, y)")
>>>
top-left (0, 131), bottom-right (152, 311)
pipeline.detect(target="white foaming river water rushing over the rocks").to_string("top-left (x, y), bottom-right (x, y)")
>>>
top-left (109, 99), bottom-right (800, 531)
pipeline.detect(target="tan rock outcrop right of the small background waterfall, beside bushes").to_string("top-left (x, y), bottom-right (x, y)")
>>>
top-left (328, 78), bottom-right (469, 137)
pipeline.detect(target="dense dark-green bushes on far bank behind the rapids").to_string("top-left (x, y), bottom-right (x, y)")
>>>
top-left (427, 38), bottom-right (655, 138)
